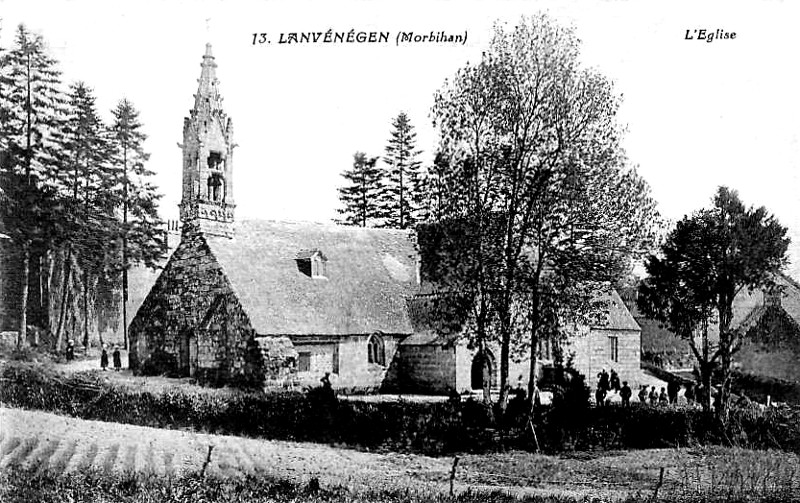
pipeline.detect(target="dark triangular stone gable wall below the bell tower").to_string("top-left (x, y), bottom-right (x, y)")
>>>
top-left (129, 226), bottom-right (263, 383)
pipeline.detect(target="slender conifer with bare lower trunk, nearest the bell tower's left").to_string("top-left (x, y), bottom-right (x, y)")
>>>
top-left (111, 99), bottom-right (164, 348)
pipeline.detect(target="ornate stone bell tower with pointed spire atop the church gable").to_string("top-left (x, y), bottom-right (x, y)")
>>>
top-left (178, 44), bottom-right (236, 238)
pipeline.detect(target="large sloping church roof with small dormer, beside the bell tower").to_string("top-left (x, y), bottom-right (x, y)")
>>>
top-left (206, 220), bottom-right (418, 336)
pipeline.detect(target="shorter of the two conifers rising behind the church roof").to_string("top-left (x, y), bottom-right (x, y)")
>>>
top-left (338, 152), bottom-right (382, 227)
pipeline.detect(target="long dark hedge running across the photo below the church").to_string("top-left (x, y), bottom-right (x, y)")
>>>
top-left (0, 362), bottom-right (800, 455)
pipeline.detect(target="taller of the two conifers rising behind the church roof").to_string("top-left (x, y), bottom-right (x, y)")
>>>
top-left (380, 112), bottom-right (423, 229)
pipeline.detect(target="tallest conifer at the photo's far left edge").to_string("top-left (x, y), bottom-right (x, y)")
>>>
top-left (0, 25), bottom-right (64, 341)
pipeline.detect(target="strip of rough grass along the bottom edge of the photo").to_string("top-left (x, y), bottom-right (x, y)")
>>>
top-left (0, 460), bottom-right (800, 503)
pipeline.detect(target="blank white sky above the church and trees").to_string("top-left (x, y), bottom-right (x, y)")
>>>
top-left (0, 0), bottom-right (800, 278)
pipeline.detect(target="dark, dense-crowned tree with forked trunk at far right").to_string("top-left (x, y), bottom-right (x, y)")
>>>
top-left (638, 187), bottom-right (789, 413)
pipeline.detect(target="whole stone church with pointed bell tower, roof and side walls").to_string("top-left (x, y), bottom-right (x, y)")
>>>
top-left (129, 45), bottom-right (641, 393)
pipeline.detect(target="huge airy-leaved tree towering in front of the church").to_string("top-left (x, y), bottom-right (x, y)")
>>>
top-left (433, 15), bottom-right (655, 412)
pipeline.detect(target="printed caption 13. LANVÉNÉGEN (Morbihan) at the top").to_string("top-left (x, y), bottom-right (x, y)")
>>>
top-left (252, 30), bottom-right (467, 45)
